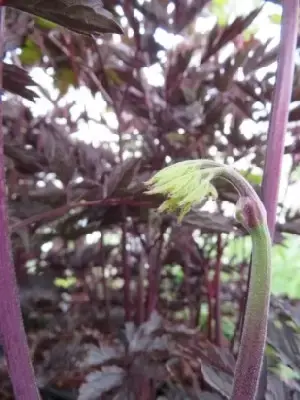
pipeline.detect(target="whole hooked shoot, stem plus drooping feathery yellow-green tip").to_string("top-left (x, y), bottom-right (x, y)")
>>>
top-left (146, 160), bottom-right (271, 400)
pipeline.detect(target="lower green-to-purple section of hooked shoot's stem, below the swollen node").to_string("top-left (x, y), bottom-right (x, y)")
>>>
top-left (231, 206), bottom-right (271, 400)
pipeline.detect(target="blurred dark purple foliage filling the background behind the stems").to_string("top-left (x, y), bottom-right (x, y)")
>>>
top-left (0, 0), bottom-right (300, 400)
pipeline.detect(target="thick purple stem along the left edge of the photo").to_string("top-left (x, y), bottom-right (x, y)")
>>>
top-left (0, 7), bottom-right (39, 400)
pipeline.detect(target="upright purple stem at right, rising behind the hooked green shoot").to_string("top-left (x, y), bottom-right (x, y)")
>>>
top-left (262, 0), bottom-right (299, 238)
